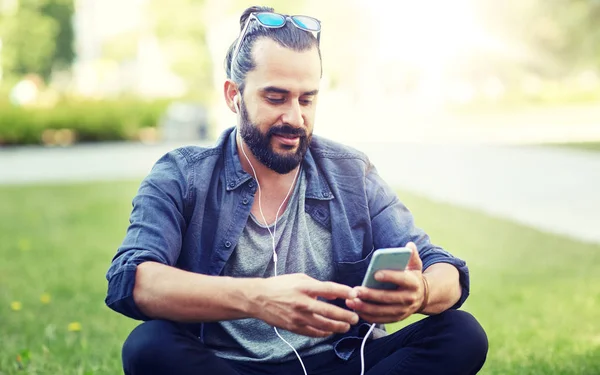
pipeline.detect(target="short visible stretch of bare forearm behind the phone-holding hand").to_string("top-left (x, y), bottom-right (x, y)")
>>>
top-left (422, 263), bottom-right (461, 315)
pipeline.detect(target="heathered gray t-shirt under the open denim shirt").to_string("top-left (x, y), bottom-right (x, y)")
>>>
top-left (209, 171), bottom-right (333, 362)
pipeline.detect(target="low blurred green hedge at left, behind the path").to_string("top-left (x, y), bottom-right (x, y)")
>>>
top-left (0, 99), bottom-right (168, 145)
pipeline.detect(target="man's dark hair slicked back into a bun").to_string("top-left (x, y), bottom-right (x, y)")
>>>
top-left (225, 6), bottom-right (322, 91)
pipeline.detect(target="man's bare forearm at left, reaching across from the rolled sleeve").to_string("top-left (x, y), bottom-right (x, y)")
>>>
top-left (133, 262), bottom-right (256, 322)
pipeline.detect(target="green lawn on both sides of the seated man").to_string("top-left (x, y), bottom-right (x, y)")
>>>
top-left (0, 181), bottom-right (600, 375)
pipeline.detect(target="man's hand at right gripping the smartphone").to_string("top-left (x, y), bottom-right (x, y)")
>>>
top-left (346, 242), bottom-right (425, 323)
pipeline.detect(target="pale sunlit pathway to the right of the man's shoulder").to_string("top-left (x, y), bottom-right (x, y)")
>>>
top-left (359, 143), bottom-right (600, 243)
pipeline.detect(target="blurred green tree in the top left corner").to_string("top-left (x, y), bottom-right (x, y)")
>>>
top-left (0, 0), bottom-right (74, 80)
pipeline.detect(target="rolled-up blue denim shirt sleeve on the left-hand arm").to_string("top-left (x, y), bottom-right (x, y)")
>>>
top-left (105, 150), bottom-right (190, 320)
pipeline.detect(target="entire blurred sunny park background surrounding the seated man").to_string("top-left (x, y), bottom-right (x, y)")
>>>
top-left (0, 0), bottom-right (600, 375)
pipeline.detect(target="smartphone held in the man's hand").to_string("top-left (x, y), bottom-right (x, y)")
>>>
top-left (362, 247), bottom-right (412, 290)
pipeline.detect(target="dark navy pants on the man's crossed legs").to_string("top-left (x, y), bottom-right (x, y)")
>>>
top-left (123, 310), bottom-right (488, 375)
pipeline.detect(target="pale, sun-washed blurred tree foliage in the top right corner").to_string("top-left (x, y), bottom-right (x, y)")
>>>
top-left (477, 0), bottom-right (600, 78)
